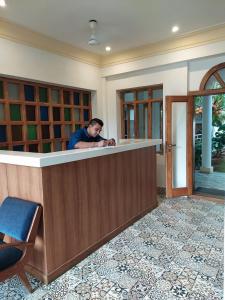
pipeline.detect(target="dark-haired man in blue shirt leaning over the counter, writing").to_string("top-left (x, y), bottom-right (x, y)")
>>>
top-left (68, 118), bottom-right (116, 150)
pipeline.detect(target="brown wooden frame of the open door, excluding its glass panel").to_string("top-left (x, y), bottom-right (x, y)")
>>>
top-left (165, 95), bottom-right (194, 197)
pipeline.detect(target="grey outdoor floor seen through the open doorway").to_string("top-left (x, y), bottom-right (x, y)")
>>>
top-left (195, 171), bottom-right (225, 191)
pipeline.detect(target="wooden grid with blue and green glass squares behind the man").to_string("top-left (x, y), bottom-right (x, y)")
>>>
top-left (0, 77), bottom-right (92, 153)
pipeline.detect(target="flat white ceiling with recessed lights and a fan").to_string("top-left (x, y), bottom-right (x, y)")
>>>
top-left (0, 0), bottom-right (225, 54)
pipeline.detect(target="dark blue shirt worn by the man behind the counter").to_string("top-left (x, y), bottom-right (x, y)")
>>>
top-left (67, 127), bottom-right (105, 150)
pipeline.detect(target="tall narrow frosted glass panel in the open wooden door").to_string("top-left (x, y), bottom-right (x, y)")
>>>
top-left (172, 102), bottom-right (187, 188)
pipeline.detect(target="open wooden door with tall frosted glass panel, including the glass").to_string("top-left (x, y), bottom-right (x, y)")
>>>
top-left (166, 96), bottom-right (193, 197)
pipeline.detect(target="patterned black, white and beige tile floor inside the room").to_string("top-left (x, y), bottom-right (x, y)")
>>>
top-left (0, 197), bottom-right (224, 300)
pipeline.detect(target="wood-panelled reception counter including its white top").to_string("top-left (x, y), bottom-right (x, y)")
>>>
top-left (0, 140), bottom-right (161, 283)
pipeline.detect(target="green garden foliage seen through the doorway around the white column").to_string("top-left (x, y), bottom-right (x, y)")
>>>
top-left (195, 94), bottom-right (225, 169)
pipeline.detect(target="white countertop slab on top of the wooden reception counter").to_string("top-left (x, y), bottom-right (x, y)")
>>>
top-left (0, 139), bottom-right (162, 168)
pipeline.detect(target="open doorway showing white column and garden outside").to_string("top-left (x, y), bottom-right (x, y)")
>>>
top-left (193, 94), bottom-right (225, 199)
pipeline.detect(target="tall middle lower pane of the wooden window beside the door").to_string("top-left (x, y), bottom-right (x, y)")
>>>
top-left (137, 104), bottom-right (148, 139)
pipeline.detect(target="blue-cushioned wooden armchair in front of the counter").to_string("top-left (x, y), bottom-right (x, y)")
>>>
top-left (0, 197), bottom-right (42, 292)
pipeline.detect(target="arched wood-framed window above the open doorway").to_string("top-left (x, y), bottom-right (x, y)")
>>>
top-left (200, 63), bottom-right (225, 91)
